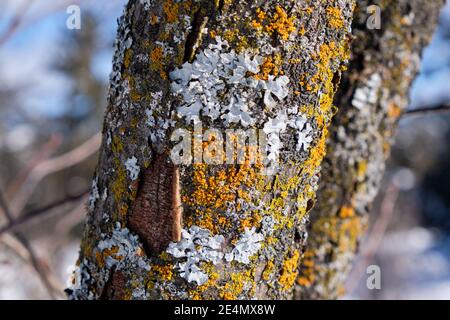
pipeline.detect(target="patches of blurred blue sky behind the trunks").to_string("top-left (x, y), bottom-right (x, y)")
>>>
top-left (0, 0), bottom-right (450, 116)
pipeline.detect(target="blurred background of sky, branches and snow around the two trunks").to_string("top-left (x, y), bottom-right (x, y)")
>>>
top-left (0, 0), bottom-right (450, 299)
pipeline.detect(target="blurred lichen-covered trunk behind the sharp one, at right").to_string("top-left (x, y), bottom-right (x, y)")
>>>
top-left (296, 0), bottom-right (444, 299)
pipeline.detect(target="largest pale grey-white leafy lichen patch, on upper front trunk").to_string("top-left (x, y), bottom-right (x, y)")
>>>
top-left (170, 37), bottom-right (289, 127)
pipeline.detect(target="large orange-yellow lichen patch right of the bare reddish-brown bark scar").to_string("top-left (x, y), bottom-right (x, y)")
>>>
top-left (182, 144), bottom-right (266, 234)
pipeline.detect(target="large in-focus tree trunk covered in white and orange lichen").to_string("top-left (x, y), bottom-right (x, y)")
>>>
top-left (68, 0), bottom-right (354, 299)
